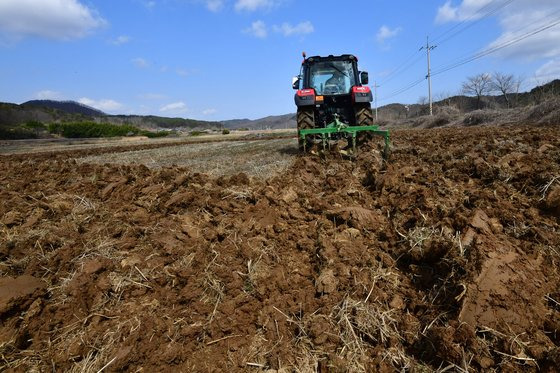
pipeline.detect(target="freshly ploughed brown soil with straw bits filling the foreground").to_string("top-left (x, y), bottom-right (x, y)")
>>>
top-left (0, 127), bottom-right (560, 372)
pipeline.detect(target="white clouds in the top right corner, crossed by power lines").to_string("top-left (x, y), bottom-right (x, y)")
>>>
top-left (436, 0), bottom-right (560, 60)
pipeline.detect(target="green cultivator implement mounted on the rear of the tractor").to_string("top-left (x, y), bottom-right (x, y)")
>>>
top-left (298, 116), bottom-right (390, 158)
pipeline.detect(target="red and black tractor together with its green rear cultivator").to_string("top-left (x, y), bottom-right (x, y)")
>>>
top-left (292, 53), bottom-right (390, 158)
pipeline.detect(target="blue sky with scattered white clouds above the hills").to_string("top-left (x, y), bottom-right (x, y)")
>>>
top-left (0, 0), bottom-right (560, 120)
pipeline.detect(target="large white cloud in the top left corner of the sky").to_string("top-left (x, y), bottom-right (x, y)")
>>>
top-left (0, 0), bottom-right (107, 40)
